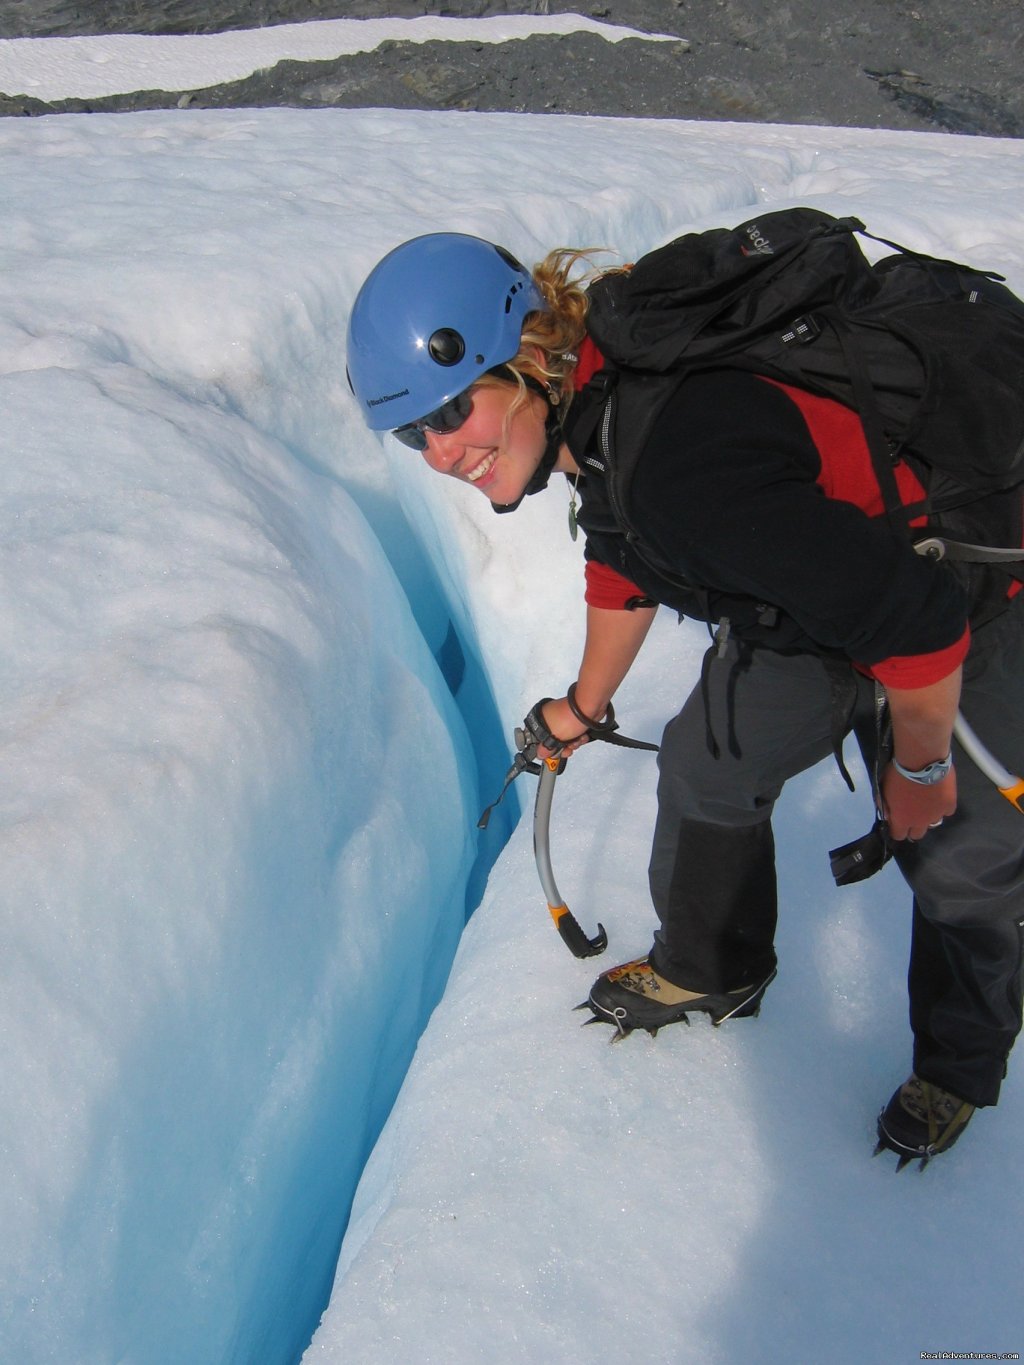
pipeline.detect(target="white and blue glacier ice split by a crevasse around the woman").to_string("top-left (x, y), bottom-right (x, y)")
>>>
top-left (0, 55), bottom-right (1024, 1365)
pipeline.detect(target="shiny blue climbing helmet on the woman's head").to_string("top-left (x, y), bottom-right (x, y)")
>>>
top-left (348, 232), bottom-right (543, 431)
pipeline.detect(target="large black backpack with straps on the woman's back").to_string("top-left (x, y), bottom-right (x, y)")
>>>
top-left (584, 209), bottom-right (1024, 624)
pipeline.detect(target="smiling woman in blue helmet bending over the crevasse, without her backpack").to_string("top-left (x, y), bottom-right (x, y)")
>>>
top-left (348, 233), bottom-right (1024, 1164)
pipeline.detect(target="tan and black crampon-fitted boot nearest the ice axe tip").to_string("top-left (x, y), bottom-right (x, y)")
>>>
top-left (578, 957), bottom-right (776, 1041)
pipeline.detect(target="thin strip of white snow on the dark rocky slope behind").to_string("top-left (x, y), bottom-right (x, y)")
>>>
top-left (0, 14), bottom-right (680, 100)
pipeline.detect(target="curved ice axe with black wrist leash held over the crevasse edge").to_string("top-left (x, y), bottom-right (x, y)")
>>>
top-left (477, 683), bottom-right (658, 957)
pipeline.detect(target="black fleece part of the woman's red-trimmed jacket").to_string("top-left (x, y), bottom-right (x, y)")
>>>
top-left (573, 370), bottom-right (967, 665)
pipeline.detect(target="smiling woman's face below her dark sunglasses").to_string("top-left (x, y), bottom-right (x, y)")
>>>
top-left (423, 382), bottom-right (547, 505)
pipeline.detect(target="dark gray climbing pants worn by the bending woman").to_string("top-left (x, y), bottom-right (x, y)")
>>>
top-left (650, 599), bottom-right (1024, 1106)
